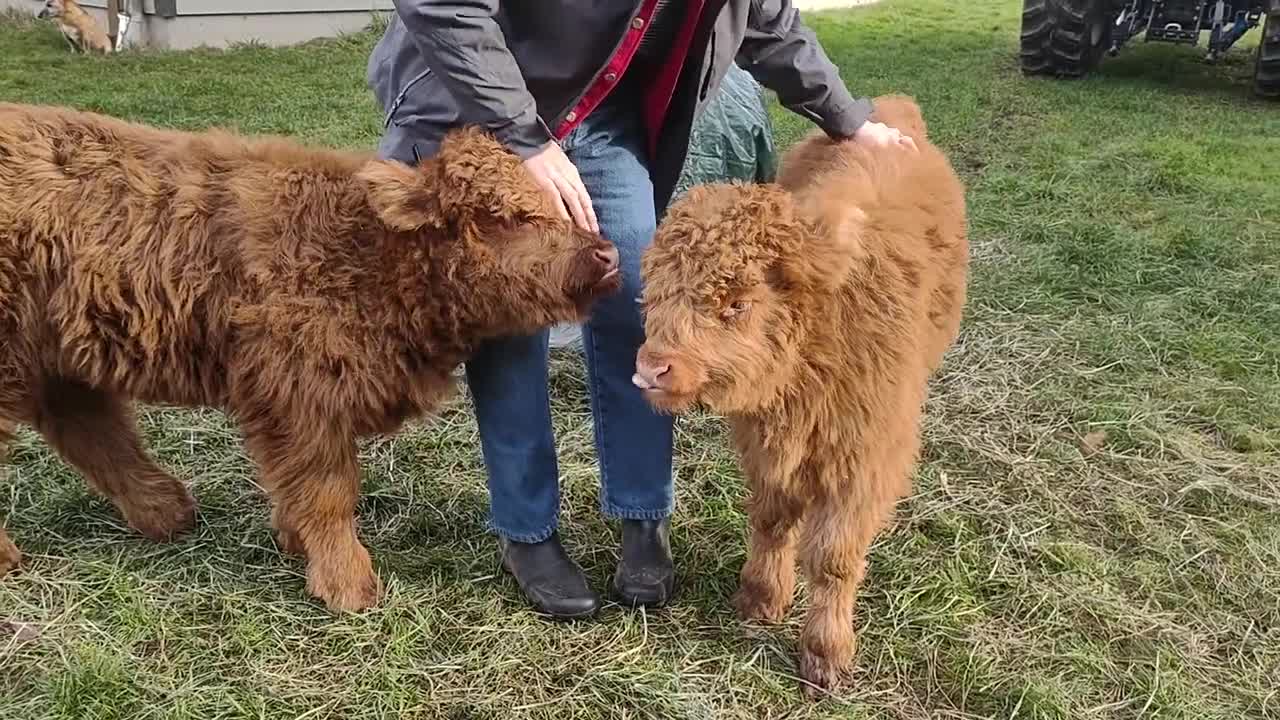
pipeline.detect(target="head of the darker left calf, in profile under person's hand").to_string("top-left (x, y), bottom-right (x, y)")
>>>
top-left (360, 128), bottom-right (622, 334)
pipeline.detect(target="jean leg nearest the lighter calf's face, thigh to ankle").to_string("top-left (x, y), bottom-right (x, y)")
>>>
top-left (566, 105), bottom-right (673, 520)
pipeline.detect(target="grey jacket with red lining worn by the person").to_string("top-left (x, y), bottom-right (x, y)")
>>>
top-left (367, 0), bottom-right (872, 208)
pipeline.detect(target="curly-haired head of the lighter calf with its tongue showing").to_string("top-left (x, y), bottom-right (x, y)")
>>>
top-left (634, 184), bottom-right (865, 413)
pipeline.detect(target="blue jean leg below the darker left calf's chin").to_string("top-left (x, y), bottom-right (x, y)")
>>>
top-left (466, 331), bottom-right (559, 542)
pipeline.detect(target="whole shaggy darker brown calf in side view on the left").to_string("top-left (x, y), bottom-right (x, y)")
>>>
top-left (0, 104), bottom-right (618, 610)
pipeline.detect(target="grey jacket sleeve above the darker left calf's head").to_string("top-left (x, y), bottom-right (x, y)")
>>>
top-left (394, 0), bottom-right (552, 158)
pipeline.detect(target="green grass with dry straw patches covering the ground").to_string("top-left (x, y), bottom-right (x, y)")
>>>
top-left (0, 0), bottom-right (1280, 720)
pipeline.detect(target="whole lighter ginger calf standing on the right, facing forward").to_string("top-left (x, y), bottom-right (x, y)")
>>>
top-left (636, 97), bottom-right (968, 689)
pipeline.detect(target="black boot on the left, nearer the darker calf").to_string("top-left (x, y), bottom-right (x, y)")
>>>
top-left (499, 533), bottom-right (600, 620)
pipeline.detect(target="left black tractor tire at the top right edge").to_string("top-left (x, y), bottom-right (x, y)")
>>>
top-left (1021, 0), bottom-right (1111, 78)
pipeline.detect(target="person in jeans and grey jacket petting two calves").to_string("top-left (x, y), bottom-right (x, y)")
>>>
top-left (367, 0), bottom-right (911, 618)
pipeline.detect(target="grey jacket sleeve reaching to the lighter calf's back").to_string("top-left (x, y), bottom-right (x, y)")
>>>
top-left (737, 0), bottom-right (873, 137)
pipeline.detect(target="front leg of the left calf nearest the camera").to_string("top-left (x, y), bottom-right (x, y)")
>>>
top-left (244, 427), bottom-right (381, 611)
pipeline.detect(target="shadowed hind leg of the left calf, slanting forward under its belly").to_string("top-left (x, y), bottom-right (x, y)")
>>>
top-left (33, 379), bottom-right (196, 541)
